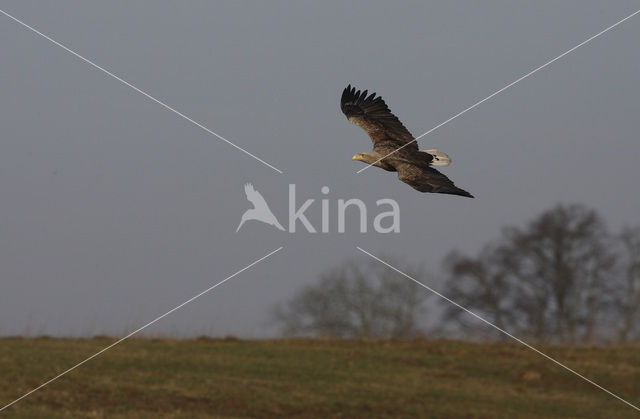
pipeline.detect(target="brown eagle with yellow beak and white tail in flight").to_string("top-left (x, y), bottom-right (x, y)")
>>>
top-left (340, 85), bottom-right (473, 198)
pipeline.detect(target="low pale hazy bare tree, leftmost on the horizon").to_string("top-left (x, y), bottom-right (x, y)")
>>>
top-left (273, 259), bottom-right (428, 338)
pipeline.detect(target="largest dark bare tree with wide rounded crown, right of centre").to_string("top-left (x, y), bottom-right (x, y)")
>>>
top-left (445, 205), bottom-right (616, 343)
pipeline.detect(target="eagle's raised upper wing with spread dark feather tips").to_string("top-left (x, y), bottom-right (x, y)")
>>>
top-left (340, 85), bottom-right (418, 151)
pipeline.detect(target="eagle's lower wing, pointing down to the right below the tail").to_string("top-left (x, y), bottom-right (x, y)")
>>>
top-left (395, 163), bottom-right (473, 198)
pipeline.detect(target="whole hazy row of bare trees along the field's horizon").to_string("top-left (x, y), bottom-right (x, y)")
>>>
top-left (272, 204), bottom-right (640, 344)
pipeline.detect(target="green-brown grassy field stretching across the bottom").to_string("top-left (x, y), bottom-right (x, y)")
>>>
top-left (0, 338), bottom-right (640, 418)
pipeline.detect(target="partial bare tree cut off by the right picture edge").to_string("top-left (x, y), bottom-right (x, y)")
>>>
top-left (616, 227), bottom-right (640, 342)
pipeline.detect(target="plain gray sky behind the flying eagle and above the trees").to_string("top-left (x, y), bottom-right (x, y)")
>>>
top-left (0, 0), bottom-right (640, 337)
